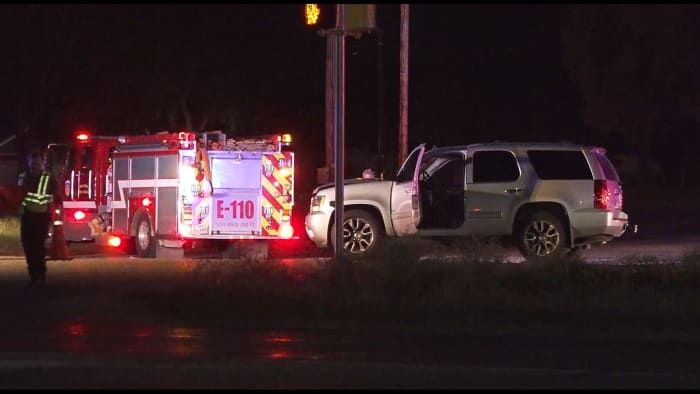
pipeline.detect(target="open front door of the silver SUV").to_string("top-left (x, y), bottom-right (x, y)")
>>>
top-left (391, 144), bottom-right (425, 236)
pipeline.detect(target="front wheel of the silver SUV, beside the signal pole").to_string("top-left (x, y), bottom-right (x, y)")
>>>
top-left (330, 209), bottom-right (383, 259)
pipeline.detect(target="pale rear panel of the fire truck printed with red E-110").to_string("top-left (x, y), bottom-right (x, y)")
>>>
top-left (211, 152), bottom-right (262, 235)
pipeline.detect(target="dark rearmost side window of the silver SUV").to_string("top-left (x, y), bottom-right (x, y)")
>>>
top-left (527, 150), bottom-right (593, 180)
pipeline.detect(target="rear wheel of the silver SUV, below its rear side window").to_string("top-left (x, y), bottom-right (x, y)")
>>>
top-left (517, 212), bottom-right (568, 261)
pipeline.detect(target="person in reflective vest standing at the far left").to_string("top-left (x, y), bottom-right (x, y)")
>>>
top-left (18, 151), bottom-right (62, 286)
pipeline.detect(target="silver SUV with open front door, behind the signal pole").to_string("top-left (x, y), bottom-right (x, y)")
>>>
top-left (305, 142), bottom-right (628, 260)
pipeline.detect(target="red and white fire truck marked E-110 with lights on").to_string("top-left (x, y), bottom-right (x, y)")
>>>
top-left (49, 131), bottom-right (294, 258)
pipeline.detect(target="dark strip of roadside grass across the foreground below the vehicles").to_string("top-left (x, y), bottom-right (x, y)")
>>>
top-left (6, 235), bottom-right (700, 336)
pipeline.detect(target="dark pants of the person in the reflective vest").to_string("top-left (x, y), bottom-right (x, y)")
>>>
top-left (20, 212), bottom-right (51, 282)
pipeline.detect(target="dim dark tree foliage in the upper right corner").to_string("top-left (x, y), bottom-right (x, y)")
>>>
top-left (562, 4), bottom-right (700, 167)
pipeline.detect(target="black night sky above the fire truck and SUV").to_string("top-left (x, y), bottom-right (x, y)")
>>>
top-left (0, 4), bottom-right (585, 172)
